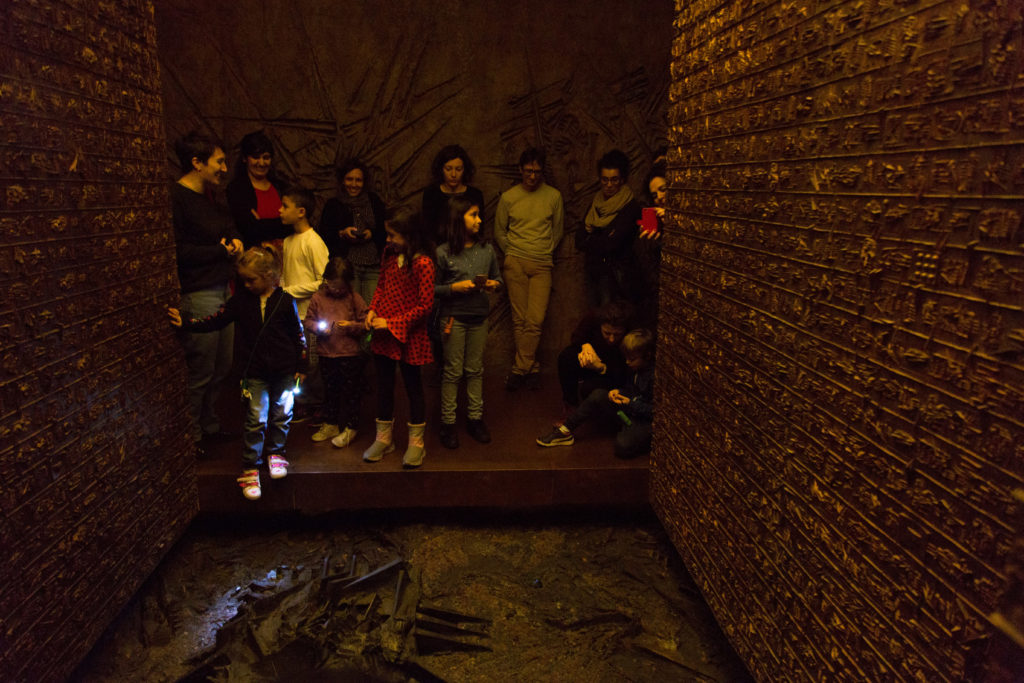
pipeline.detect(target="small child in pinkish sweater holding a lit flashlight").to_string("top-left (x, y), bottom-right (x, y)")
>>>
top-left (302, 256), bottom-right (367, 449)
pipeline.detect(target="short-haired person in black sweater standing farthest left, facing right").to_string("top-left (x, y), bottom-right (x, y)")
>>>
top-left (171, 131), bottom-right (242, 456)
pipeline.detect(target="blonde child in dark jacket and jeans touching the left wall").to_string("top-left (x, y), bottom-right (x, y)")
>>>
top-left (168, 247), bottom-right (307, 501)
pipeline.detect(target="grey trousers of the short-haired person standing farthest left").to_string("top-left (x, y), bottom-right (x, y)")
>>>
top-left (181, 285), bottom-right (234, 441)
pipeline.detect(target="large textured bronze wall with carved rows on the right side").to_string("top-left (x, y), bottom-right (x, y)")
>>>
top-left (652, 0), bottom-right (1024, 681)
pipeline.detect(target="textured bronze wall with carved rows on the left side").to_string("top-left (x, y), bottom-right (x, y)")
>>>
top-left (0, 0), bottom-right (198, 681)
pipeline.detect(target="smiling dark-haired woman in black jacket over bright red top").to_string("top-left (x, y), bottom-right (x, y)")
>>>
top-left (227, 130), bottom-right (292, 249)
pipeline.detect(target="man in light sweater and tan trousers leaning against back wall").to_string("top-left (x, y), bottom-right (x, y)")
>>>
top-left (495, 147), bottom-right (564, 391)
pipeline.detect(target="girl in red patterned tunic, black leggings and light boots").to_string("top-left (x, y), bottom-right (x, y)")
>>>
top-left (362, 207), bottom-right (434, 467)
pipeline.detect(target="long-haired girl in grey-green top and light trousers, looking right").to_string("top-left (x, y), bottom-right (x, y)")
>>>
top-left (434, 197), bottom-right (502, 449)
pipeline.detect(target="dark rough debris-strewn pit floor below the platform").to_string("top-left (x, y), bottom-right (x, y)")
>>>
top-left (72, 511), bottom-right (751, 683)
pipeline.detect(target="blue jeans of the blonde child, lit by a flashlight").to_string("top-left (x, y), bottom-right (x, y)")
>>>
top-left (242, 375), bottom-right (295, 468)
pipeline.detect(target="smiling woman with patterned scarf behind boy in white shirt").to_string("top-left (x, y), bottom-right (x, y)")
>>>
top-left (318, 159), bottom-right (387, 301)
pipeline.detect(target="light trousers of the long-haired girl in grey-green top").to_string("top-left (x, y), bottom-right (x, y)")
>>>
top-left (441, 321), bottom-right (487, 425)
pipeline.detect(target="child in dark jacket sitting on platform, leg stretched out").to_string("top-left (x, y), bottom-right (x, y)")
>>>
top-left (537, 329), bottom-right (654, 458)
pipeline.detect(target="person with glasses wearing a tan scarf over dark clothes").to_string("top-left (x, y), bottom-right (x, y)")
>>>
top-left (575, 150), bottom-right (643, 308)
